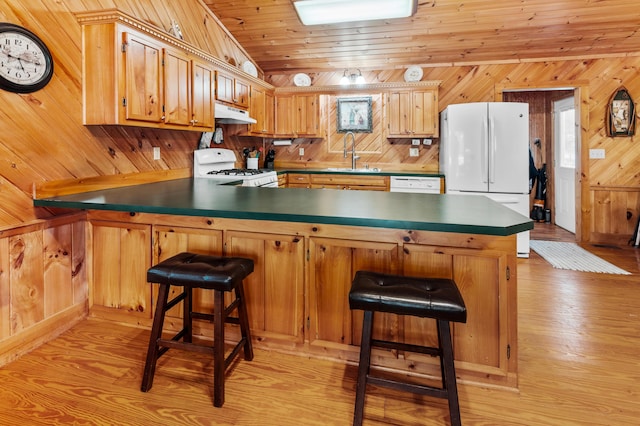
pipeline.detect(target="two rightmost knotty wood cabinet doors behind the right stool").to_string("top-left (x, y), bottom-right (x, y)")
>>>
top-left (309, 238), bottom-right (515, 383)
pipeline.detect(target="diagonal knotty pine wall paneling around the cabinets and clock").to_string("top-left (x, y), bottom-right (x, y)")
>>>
top-left (0, 0), bottom-right (640, 238)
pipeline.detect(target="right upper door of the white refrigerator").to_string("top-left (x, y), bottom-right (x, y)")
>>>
top-left (488, 102), bottom-right (529, 194)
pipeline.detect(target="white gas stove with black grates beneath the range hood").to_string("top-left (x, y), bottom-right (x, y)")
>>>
top-left (193, 148), bottom-right (278, 188)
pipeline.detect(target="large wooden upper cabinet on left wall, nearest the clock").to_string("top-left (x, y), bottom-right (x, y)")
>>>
top-left (82, 14), bottom-right (231, 132)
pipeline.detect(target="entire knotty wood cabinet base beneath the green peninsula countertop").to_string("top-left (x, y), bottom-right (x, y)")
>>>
top-left (88, 212), bottom-right (517, 387)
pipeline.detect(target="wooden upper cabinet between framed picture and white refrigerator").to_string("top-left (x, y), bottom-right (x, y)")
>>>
top-left (386, 88), bottom-right (438, 138)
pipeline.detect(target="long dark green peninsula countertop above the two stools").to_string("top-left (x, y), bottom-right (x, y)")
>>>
top-left (34, 178), bottom-right (533, 235)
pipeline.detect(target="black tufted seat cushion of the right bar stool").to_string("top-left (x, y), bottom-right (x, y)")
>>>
top-left (349, 271), bottom-right (467, 323)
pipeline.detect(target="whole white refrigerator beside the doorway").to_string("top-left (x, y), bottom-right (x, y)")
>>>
top-left (440, 102), bottom-right (530, 257)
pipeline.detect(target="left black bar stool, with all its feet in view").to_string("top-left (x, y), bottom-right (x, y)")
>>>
top-left (141, 252), bottom-right (253, 407)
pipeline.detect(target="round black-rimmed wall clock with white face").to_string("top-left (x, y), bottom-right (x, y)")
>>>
top-left (0, 22), bottom-right (53, 93)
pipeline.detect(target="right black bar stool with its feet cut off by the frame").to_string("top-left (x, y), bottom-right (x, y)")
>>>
top-left (349, 271), bottom-right (467, 426)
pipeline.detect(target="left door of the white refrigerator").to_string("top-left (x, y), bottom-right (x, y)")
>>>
top-left (440, 103), bottom-right (489, 192)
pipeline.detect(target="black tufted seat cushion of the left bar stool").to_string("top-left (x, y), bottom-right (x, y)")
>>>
top-left (147, 252), bottom-right (253, 291)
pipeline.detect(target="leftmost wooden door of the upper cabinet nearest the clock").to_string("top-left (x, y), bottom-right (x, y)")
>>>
top-left (123, 32), bottom-right (163, 123)
